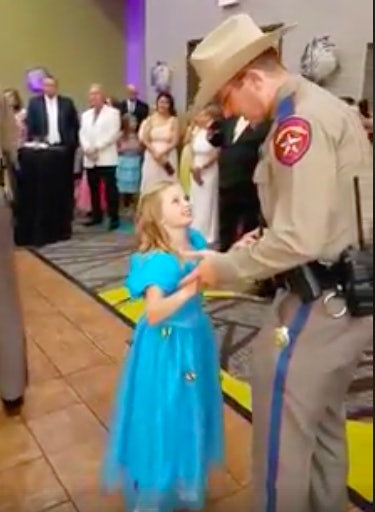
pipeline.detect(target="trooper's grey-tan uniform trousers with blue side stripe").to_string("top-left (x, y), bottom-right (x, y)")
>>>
top-left (251, 293), bottom-right (373, 512)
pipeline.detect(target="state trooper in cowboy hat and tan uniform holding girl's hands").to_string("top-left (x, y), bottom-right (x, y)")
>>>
top-left (181, 14), bottom-right (373, 512)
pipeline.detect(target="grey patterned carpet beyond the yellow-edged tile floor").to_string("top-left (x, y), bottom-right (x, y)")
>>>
top-left (35, 220), bottom-right (373, 419)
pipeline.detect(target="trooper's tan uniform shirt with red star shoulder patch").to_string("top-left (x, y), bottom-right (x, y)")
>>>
top-left (214, 77), bottom-right (373, 285)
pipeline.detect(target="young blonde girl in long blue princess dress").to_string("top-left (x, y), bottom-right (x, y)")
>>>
top-left (104, 182), bottom-right (223, 512)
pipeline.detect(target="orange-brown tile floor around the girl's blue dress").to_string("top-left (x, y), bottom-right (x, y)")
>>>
top-left (0, 252), bottom-right (362, 512)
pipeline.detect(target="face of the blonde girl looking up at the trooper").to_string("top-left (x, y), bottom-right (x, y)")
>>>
top-left (161, 184), bottom-right (193, 229)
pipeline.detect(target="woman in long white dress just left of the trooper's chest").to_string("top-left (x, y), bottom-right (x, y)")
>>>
top-left (190, 106), bottom-right (219, 244)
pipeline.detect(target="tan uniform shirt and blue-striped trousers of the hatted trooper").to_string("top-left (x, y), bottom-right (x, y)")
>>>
top-left (212, 77), bottom-right (373, 512)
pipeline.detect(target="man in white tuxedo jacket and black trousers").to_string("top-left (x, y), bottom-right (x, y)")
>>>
top-left (79, 84), bottom-right (121, 230)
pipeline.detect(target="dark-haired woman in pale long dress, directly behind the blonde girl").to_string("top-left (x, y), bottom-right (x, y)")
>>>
top-left (139, 92), bottom-right (179, 192)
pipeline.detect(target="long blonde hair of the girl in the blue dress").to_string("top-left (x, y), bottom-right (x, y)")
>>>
top-left (136, 181), bottom-right (176, 253)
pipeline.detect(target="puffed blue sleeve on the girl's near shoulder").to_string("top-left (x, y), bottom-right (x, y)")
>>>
top-left (125, 252), bottom-right (181, 299)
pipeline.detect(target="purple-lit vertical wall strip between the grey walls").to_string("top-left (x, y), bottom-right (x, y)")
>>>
top-left (124, 0), bottom-right (146, 95)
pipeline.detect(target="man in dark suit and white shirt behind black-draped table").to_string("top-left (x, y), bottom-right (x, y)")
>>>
top-left (26, 76), bottom-right (79, 239)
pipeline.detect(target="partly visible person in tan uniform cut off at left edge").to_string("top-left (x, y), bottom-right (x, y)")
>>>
top-left (0, 92), bottom-right (27, 413)
